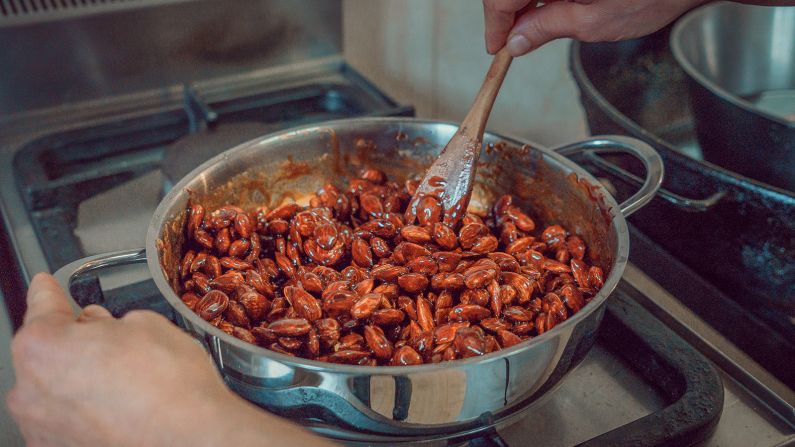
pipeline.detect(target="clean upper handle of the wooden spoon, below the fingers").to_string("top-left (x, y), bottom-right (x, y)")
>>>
top-left (461, 47), bottom-right (513, 140)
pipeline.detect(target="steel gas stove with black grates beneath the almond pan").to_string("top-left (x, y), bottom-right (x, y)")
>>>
top-left (0, 60), bottom-right (795, 446)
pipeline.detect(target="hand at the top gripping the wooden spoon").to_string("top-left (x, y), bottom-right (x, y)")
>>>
top-left (483, 0), bottom-right (706, 57)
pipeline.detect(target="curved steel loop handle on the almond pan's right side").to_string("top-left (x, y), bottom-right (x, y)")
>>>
top-left (553, 135), bottom-right (665, 217)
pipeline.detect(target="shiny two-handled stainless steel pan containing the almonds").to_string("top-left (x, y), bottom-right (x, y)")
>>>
top-left (56, 118), bottom-right (663, 442)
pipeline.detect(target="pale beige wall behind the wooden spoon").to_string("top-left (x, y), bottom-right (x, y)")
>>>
top-left (343, 0), bottom-right (587, 145)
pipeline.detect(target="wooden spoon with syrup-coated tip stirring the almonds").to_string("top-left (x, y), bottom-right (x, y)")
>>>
top-left (406, 47), bottom-right (513, 227)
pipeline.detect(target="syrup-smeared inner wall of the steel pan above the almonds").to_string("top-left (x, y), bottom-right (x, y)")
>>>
top-left (157, 124), bottom-right (618, 300)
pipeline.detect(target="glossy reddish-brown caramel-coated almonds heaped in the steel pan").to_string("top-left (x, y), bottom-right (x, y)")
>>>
top-left (180, 169), bottom-right (604, 366)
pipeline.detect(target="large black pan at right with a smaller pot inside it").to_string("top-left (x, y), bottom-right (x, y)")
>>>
top-left (570, 28), bottom-right (795, 388)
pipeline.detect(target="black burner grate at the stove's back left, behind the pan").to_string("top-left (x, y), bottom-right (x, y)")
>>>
top-left (14, 75), bottom-right (414, 270)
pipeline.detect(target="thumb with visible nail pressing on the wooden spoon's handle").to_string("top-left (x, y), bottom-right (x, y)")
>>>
top-left (506, 2), bottom-right (593, 57)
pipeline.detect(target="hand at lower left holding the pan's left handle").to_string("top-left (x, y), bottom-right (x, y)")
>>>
top-left (7, 274), bottom-right (336, 447)
